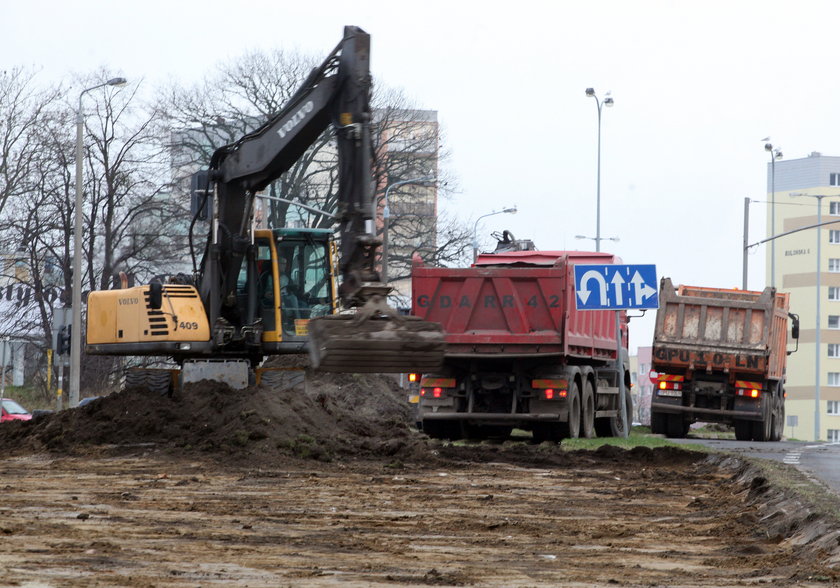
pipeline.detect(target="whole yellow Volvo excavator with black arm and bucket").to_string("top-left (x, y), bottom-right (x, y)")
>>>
top-left (85, 27), bottom-right (445, 389)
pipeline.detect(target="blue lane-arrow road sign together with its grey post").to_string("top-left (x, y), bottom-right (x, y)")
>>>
top-left (575, 264), bottom-right (659, 438)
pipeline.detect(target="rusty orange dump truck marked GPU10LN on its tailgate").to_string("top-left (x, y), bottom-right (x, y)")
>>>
top-left (650, 278), bottom-right (799, 441)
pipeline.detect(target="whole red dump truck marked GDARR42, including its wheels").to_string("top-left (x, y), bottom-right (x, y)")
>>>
top-left (412, 243), bottom-right (632, 441)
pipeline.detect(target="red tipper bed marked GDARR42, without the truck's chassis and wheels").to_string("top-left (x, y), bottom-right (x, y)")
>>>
top-left (412, 251), bottom-right (626, 360)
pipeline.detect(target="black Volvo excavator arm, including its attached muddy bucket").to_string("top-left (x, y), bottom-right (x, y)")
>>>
top-left (199, 27), bottom-right (444, 372)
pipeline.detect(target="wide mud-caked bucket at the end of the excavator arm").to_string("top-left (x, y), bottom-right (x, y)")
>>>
top-left (309, 314), bottom-right (446, 373)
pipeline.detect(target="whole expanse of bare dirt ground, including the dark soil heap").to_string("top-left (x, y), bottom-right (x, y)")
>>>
top-left (0, 366), bottom-right (840, 586)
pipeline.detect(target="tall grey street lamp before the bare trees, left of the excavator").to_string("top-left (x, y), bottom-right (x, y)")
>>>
top-left (70, 78), bottom-right (126, 408)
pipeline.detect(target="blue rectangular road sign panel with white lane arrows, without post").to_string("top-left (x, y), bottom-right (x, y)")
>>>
top-left (575, 265), bottom-right (659, 310)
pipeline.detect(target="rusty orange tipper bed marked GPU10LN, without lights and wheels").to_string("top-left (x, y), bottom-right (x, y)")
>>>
top-left (653, 278), bottom-right (788, 379)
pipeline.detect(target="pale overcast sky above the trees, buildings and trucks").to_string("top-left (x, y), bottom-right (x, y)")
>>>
top-left (0, 0), bottom-right (840, 348)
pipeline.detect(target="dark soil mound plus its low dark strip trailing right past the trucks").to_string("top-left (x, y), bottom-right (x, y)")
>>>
top-left (0, 357), bottom-right (701, 467)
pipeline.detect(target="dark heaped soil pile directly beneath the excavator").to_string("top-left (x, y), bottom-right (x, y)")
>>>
top-left (0, 358), bottom-right (425, 464)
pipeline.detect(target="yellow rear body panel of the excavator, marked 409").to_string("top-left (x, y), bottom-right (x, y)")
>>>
top-left (87, 284), bottom-right (210, 345)
